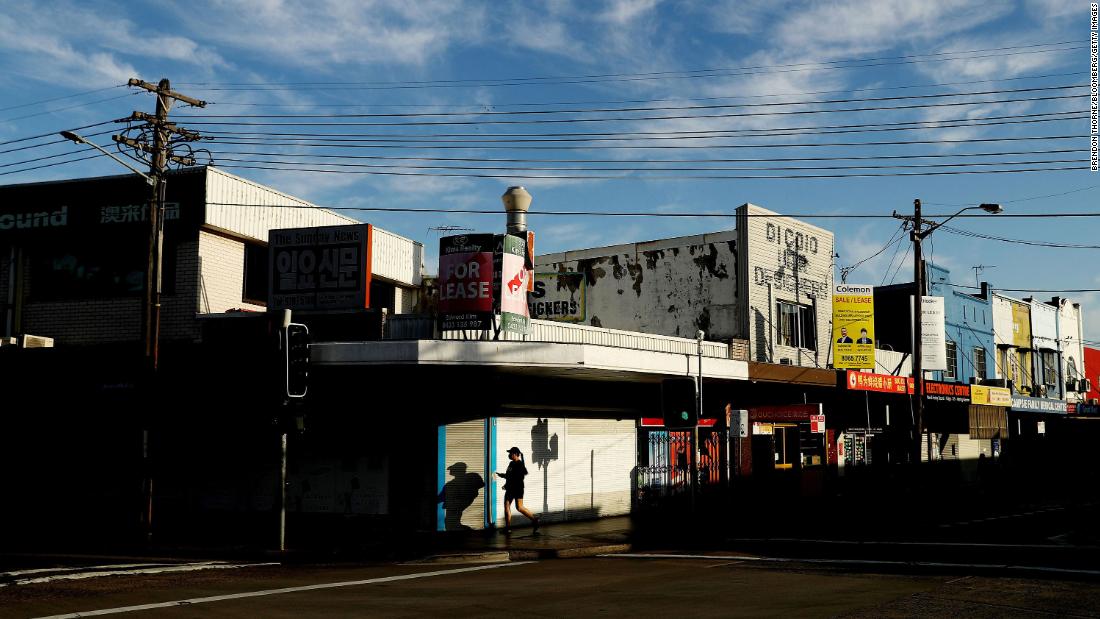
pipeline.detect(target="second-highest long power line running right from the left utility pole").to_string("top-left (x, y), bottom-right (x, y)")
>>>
top-left (208, 71), bottom-right (1088, 109)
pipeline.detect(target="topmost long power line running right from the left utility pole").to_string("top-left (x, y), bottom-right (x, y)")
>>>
top-left (176, 41), bottom-right (1088, 91)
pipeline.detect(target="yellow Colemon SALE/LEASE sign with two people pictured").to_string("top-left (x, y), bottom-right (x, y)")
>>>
top-left (833, 284), bottom-right (875, 369)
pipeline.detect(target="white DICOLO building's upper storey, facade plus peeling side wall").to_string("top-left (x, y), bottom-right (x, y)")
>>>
top-left (534, 205), bottom-right (833, 368)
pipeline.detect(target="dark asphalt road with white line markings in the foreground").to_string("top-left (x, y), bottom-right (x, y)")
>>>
top-left (0, 553), bottom-right (1100, 617)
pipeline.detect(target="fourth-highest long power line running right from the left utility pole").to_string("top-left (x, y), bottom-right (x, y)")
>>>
top-left (176, 92), bottom-right (1088, 126)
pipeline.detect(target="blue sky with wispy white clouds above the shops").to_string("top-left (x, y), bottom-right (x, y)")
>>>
top-left (0, 0), bottom-right (1100, 340)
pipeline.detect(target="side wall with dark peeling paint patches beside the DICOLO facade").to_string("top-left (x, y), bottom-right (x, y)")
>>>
top-left (535, 231), bottom-right (745, 341)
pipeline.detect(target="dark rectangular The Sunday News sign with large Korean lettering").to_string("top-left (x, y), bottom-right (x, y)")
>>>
top-left (267, 223), bottom-right (371, 310)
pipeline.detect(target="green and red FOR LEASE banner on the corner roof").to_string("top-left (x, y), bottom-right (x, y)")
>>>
top-left (439, 234), bottom-right (495, 331)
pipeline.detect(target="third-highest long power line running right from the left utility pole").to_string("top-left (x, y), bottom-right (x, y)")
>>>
top-left (173, 84), bottom-right (1088, 119)
